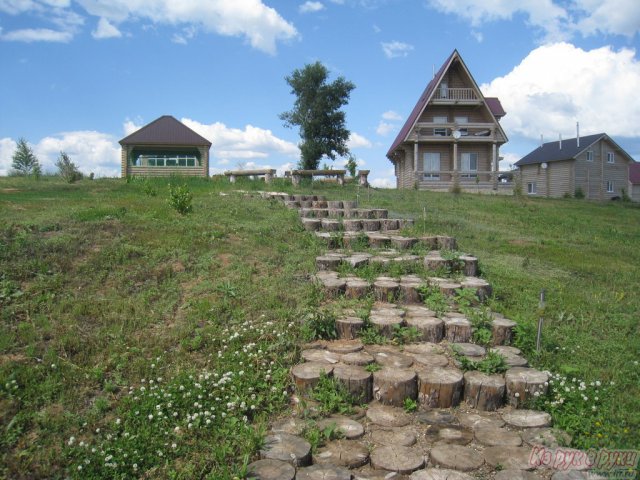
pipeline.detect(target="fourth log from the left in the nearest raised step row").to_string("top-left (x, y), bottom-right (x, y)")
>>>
top-left (418, 367), bottom-right (463, 408)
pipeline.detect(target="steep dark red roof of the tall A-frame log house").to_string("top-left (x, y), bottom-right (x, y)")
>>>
top-left (387, 50), bottom-right (507, 161)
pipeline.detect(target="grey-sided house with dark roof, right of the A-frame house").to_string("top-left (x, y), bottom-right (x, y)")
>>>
top-left (515, 133), bottom-right (634, 200)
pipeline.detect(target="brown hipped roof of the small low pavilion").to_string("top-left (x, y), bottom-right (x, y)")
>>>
top-left (120, 115), bottom-right (211, 147)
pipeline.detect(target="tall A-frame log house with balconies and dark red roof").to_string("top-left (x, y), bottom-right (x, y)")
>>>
top-left (387, 50), bottom-right (507, 190)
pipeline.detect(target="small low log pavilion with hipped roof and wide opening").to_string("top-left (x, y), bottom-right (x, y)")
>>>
top-left (120, 115), bottom-right (211, 177)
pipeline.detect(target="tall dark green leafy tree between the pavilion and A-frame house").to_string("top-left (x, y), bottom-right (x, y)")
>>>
top-left (280, 62), bottom-right (355, 170)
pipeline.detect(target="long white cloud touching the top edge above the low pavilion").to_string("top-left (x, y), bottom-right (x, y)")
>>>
top-left (78, 0), bottom-right (298, 54)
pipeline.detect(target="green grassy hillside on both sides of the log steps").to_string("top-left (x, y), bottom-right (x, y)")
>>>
top-left (0, 178), bottom-right (640, 479)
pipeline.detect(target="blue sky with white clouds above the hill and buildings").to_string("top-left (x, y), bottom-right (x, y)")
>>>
top-left (0, 0), bottom-right (640, 187)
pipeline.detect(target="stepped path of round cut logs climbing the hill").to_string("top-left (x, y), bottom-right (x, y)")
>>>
top-left (244, 193), bottom-right (599, 480)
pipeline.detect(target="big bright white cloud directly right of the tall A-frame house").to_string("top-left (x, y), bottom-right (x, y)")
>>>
top-left (481, 43), bottom-right (640, 140)
